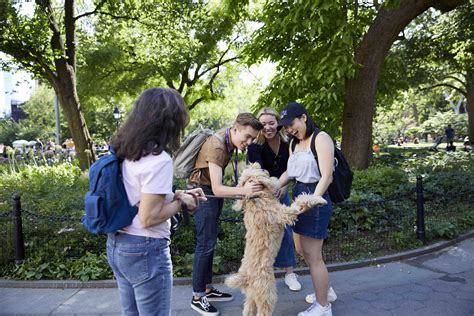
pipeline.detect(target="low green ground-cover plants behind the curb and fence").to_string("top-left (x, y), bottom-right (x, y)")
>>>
top-left (0, 149), bottom-right (474, 281)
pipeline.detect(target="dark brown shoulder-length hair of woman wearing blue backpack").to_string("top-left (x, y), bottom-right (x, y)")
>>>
top-left (111, 88), bottom-right (189, 161)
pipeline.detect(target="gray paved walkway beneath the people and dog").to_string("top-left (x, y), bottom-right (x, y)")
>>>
top-left (0, 237), bottom-right (474, 316)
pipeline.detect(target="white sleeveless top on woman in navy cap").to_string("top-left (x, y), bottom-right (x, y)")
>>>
top-left (287, 150), bottom-right (321, 183)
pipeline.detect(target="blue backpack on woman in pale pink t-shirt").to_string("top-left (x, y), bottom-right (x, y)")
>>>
top-left (82, 148), bottom-right (138, 234)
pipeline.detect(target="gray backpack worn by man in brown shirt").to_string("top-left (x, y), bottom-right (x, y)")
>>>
top-left (174, 125), bottom-right (224, 179)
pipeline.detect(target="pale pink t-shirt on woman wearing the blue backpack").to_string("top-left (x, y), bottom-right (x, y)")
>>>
top-left (120, 151), bottom-right (173, 239)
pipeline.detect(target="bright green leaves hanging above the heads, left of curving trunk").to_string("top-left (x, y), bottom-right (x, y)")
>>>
top-left (245, 1), bottom-right (360, 135)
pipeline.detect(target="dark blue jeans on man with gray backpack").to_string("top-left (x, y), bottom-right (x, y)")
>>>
top-left (193, 186), bottom-right (224, 296)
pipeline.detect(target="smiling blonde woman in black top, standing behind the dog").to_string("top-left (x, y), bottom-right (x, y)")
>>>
top-left (247, 108), bottom-right (301, 291)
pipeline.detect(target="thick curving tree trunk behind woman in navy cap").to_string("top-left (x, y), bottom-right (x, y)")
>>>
top-left (342, 0), bottom-right (465, 168)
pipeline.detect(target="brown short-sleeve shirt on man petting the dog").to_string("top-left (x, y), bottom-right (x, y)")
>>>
top-left (189, 129), bottom-right (230, 186)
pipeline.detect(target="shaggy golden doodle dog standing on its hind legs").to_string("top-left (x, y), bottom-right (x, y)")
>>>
top-left (225, 163), bottom-right (327, 316)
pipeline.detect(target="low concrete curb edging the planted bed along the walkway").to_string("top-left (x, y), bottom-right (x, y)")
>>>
top-left (0, 230), bottom-right (474, 289)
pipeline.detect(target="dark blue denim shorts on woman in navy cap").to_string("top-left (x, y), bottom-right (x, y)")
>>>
top-left (293, 182), bottom-right (332, 239)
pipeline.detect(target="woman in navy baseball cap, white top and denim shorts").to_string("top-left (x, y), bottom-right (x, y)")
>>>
top-left (278, 102), bottom-right (337, 316)
